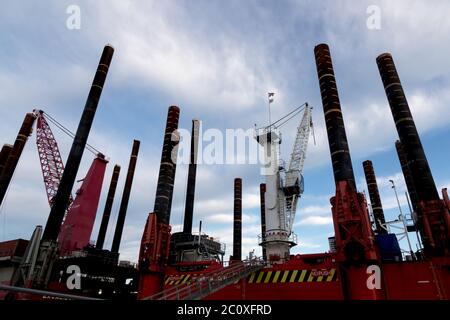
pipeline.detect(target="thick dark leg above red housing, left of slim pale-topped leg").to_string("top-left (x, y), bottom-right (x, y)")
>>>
top-left (153, 106), bottom-right (180, 225)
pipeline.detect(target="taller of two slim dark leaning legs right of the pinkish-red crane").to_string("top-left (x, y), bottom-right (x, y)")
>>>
top-left (111, 140), bottom-right (141, 252)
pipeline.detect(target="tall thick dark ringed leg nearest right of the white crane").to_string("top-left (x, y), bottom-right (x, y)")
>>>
top-left (314, 43), bottom-right (356, 190)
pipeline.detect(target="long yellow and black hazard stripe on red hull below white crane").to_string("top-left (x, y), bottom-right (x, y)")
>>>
top-left (247, 268), bottom-right (337, 283)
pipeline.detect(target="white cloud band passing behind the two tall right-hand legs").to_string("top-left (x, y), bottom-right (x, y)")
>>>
top-left (305, 89), bottom-right (450, 169)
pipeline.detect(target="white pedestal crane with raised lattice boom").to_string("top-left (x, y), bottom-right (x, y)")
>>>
top-left (255, 103), bottom-right (314, 263)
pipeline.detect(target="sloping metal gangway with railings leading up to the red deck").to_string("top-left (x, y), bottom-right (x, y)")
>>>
top-left (144, 260), bottom-right (265, 300)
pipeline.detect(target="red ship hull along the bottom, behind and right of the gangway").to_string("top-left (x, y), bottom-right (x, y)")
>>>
top-left (165, 255), bottom-right (450, 300)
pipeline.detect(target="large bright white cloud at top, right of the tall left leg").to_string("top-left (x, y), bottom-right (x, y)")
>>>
top-left (91, 1), bottom-right (273, 113)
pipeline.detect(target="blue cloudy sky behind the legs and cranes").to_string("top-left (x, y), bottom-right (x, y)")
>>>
top-left (0, 0), bottom-right (450, 262)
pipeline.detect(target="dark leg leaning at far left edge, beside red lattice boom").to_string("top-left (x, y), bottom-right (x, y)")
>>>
top-left (0, 113), bottom-right (36, 205)
